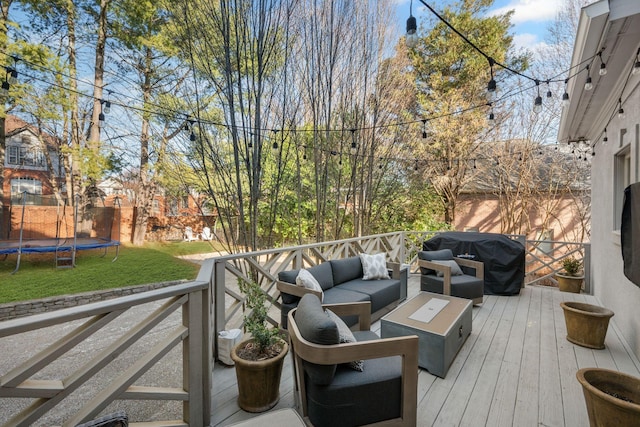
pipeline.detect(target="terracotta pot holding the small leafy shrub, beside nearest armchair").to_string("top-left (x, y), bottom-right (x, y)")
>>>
top-left (231, 341), bottom-right (289, 412)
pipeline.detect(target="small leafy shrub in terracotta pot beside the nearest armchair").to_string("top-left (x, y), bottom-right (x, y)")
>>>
top-left (231, 281), bottom-right (289, 412)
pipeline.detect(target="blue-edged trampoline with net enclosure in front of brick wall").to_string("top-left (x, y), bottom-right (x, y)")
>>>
top-left (0, 193), bottom-right (120, 274)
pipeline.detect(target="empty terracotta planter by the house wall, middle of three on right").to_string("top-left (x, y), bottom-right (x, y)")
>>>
top-left (560, 301), bottom-right (613, 349)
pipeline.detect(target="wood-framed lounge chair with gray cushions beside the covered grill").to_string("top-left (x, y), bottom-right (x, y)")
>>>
top-left (418, 249), bottom-right (484, 305)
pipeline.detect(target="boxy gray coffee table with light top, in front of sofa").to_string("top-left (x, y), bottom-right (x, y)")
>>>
top-left (380, 292), bottom-right (473, 378)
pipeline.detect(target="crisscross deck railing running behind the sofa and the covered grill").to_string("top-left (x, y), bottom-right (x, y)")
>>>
top-left (211, 231), bottom-right (591, 356)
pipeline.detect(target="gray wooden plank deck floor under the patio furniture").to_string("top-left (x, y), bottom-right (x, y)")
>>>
top-left (211, 276), bottom-right (640, 427)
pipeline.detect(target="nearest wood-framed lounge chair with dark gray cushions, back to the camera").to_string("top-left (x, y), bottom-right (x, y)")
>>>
top-left (288, 294), bottom-right (418, 427)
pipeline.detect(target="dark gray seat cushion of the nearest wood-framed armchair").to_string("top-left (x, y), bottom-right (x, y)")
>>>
top-left (307, 331), bottom-right (402, 427)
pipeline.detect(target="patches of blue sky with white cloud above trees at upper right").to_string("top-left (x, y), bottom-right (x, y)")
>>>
top-left (394, 0), bottom-right (562, 48)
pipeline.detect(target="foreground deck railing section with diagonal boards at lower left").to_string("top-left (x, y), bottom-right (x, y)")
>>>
top-left (0, 280), bottom-right (212, 426)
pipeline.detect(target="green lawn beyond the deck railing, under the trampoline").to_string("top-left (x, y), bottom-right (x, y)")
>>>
top-left (0, 242), bottom-right (225, 303)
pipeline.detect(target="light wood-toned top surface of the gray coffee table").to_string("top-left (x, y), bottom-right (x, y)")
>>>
top-left (381, 292), bottom-right (472, 335)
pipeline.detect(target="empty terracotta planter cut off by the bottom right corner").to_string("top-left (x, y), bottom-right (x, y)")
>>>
top-left (576, 368), bottom-right (640, 427)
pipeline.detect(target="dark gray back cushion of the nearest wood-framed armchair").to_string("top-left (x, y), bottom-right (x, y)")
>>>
top-left (295, 294), bottom-right (340, 385)
